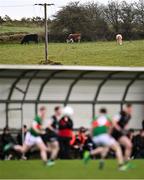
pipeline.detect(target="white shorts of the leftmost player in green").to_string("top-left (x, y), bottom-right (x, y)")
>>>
top-left (24, 132), bottom-right (43, 146)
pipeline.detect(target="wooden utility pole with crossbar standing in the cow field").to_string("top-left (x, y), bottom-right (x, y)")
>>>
top-left (35, 3), bottom-right (54, 64)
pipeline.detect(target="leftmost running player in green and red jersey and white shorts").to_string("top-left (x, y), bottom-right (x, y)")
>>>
top-left (4, 106), bottom-right (48, 165)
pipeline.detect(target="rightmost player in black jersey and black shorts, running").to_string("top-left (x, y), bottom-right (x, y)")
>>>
top-left (112, 104), bottom-right (132, 163)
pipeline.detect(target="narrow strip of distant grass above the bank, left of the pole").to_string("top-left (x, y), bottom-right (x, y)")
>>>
top-left (0, 25), bottom-right (44, 34)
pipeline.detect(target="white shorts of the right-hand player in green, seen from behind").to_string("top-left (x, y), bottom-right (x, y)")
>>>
top-left (93, 134), bottom-right (116, 146)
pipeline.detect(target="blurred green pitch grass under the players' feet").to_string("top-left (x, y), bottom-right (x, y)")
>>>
top-left (0, 160), bottom-right (144, 179)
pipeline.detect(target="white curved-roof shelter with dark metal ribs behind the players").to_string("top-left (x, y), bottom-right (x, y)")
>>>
top-left (0, 65), bottom-right (144, 129)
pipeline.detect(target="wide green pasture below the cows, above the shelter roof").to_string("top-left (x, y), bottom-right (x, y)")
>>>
top-left (0, 41), bottom-right (144, 66)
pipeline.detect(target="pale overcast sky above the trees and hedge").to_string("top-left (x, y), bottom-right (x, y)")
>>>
top-left (0, 0), bottom-right (137, 19)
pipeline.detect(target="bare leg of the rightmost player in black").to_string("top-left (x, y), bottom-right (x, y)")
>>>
top-left (119, 136), bottom-right (132, 162)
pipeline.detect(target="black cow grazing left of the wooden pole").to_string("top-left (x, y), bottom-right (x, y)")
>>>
top-left (21, 34), bottom-right (38, 44)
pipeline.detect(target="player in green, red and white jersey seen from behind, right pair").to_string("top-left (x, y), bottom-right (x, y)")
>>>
top-left (84, 108), bottom-right (127, 171)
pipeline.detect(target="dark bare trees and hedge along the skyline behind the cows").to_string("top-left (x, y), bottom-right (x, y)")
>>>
top-left (0, 0), bottom-right (144, 42)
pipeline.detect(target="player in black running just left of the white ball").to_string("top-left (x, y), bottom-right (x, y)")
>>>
top-left (42, 106), bottom-right (62, 165)
